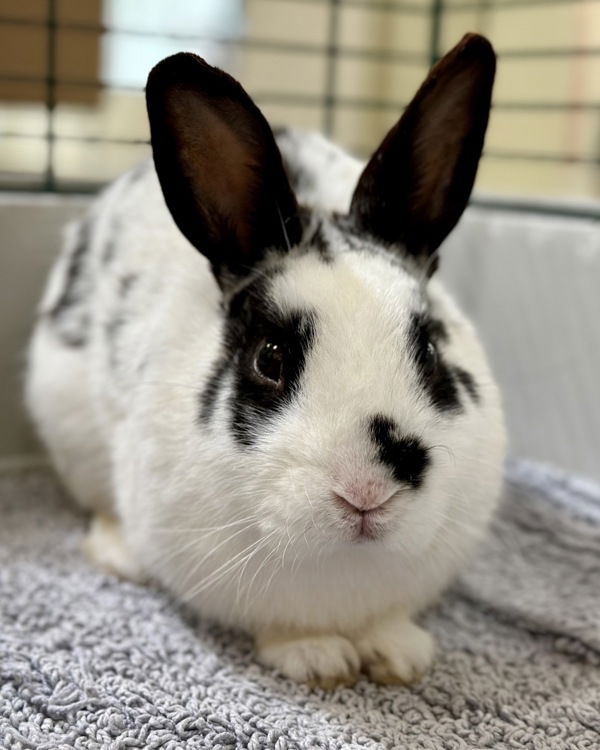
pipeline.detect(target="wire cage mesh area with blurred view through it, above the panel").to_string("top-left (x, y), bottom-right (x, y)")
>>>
top-left (0, 0), bottom-right (600, 214)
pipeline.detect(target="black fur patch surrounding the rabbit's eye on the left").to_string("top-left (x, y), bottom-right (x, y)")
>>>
top-left (200, 276), bottom-right (314, 447)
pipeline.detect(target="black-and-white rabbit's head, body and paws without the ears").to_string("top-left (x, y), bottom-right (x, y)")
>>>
top-left (27, 38), bottom-right (504, 685)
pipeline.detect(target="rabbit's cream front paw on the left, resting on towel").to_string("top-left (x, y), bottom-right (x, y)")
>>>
top-left (257, 635), bottom-right (360, 689)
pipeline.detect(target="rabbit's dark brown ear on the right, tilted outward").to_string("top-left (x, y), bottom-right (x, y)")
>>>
top-left (350, 34), bottom-right (496, 272)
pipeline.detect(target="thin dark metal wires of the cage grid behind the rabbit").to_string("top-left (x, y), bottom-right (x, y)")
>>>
top-left (0, 0), bottom-right (600, 217)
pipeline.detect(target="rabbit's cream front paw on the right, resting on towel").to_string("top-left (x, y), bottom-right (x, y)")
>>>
top-left (356, 615), bottom-right (435, 685)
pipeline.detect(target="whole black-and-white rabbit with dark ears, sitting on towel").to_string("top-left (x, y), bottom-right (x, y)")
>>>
top-left (26, 34), bottom-right (506, 688)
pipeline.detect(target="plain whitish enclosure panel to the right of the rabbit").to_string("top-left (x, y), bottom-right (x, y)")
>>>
top-left (441, 208), bottom-right (600, 479)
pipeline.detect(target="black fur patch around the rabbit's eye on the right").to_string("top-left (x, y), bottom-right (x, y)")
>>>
top-left (409, 313), bottom-right (462, 412)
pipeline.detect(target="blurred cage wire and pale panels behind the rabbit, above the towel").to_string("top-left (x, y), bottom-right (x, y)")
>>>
top-left (0, 0), bottom-right (600, 478)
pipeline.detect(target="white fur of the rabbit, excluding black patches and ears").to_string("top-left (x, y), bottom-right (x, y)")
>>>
top-left (27, 131), bottom-right (505, 682)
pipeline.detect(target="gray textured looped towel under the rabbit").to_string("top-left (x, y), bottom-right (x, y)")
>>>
top-left (0, 463), bottom-right (600, 750)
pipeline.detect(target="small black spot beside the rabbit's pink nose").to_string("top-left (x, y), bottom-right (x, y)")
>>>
top-left (369, 414), bottom-right (430, 489)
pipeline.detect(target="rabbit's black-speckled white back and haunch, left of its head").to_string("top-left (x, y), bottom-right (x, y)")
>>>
top-left (26, 162), bottom-right (214, 510)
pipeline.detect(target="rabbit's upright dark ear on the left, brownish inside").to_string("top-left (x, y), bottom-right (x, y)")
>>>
top-left (146, 53), bottom-right (301, 286)
